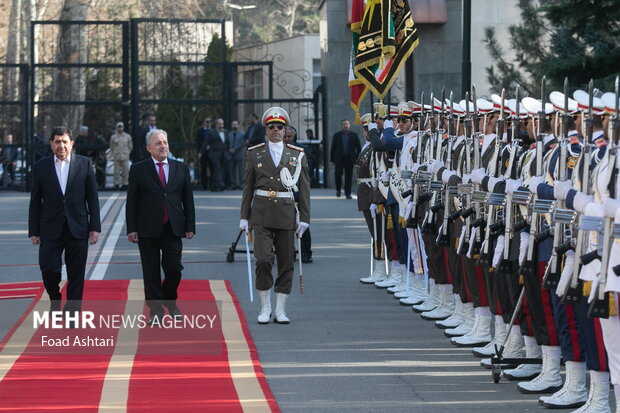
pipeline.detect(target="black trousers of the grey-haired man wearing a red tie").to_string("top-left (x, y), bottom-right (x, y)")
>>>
top-left (138, 221), bottom-right (183, 316)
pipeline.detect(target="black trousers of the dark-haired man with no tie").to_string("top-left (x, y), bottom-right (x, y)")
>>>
top-left (39, 222), bottom-right (88, 306)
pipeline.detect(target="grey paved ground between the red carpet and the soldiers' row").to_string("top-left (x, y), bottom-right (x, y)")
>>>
top-left (0, 189), bottom-right (572, 412)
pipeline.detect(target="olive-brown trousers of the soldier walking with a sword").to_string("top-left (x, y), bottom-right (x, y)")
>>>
top-left (254, 225), bottom-right (294, 294)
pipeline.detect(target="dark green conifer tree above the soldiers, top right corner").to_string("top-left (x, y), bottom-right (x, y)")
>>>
top-left (485, 0), bottom-right (620, 96)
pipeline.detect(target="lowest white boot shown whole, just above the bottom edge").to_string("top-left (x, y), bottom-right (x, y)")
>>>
top-left (538, 361), bottom-right (588, 409)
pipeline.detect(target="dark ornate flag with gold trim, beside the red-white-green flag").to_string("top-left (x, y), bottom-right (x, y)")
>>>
top-left (354, 0), bottom-right (419, 99)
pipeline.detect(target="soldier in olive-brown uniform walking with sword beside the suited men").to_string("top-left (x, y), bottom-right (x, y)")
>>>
top-left (239, 106), bottom-right (310, 324)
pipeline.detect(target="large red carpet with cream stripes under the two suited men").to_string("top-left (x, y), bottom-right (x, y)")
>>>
top-left (0, 280), bottom-right (279, 413)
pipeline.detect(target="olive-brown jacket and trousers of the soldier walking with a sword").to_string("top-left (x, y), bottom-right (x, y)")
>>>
top-left (241, 143), bottom-right (310, 294)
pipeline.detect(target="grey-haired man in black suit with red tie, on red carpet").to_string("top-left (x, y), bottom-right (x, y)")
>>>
top-left (125, 129), bottom-right (196, 323)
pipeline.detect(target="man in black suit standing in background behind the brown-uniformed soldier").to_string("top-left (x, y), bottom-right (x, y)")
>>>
top-left (331, 119), bottom-right (361, 199)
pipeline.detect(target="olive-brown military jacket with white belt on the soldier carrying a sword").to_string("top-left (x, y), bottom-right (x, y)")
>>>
top-left (241, 143), bottom-right (310, 230)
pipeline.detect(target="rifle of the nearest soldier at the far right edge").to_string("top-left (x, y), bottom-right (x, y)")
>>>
top-left (588, 77), bottom-right (620, 318)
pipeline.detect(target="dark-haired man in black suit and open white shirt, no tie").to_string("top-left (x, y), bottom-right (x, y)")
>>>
top-left (28, 126), bottom-right (101, 311)
